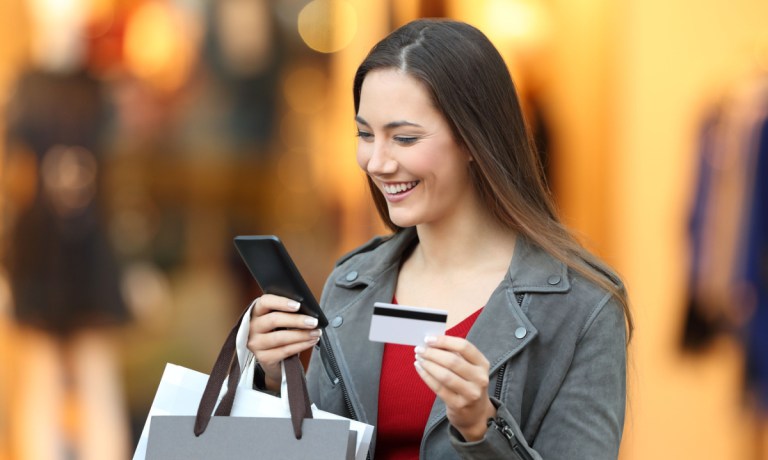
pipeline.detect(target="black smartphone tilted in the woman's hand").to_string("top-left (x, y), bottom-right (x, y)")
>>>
top-left (234, 235), bottom-right (328, 328)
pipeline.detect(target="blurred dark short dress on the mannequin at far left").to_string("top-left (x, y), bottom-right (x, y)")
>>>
top-left (7, 73), bottom-right (129, 335)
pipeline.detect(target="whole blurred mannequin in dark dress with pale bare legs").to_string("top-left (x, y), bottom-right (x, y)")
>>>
top-left (5, 72), bottom-right (129, 460)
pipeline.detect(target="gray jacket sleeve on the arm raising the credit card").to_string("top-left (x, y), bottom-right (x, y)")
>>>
top-left (450, 298), bottom-right (626, 460)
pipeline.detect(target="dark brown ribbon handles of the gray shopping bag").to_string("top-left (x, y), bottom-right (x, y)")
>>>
top-left (194, 309), bottom-right (312, 439)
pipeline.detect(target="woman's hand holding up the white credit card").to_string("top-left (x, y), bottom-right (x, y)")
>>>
top-left (414, 335), bottom-right (496, 441)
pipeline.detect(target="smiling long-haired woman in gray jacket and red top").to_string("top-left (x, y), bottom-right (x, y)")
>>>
top-left (248, 19), bottom-right (631, 459)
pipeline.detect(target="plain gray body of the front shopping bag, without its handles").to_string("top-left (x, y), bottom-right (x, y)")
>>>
top-left (146, 415), bottom-right (356, 460)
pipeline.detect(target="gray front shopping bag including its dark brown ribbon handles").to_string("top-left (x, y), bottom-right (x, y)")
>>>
top-left (145, 302), bottom-right (357, 460)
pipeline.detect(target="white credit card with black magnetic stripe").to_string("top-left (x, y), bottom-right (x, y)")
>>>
top-left (368, 302), bottom-right (448, 345)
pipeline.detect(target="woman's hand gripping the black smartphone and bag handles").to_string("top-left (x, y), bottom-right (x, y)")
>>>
top-left (248, 294), bottom-right (322, 391)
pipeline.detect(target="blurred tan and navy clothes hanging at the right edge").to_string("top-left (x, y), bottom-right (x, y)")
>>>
top-left (683, 76), bottom-right (768, 415)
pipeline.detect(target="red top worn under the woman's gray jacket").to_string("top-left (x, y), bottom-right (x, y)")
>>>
top-left (376, 300), bottom-right (482, 460)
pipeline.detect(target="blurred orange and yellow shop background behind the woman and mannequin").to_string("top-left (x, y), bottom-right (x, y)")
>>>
top-left (0, 0), bottom-right (768, 460)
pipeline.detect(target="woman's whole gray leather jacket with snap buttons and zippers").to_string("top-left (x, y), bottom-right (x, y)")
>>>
top-left (307, 229), bottom-right (626, 460)
